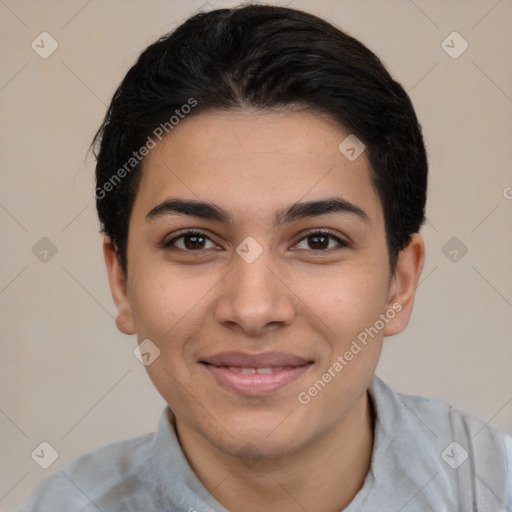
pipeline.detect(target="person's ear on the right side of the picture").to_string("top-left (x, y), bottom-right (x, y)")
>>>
top-left (384, 233), bottom-right (425, 336)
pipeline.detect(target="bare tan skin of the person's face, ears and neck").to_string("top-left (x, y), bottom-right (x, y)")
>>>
top-left (104, 111), bottom-right (424, 512)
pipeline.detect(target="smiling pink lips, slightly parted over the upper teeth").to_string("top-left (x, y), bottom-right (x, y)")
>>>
top-left (201, 352), bottom-right (313, 396)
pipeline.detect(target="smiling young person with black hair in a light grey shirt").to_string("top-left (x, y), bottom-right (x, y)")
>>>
top-left (13, 5), bottom-right (512, 512)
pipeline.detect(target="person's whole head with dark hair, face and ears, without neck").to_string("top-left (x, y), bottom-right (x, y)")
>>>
top-left (95, 5), bottom-right (427, 457)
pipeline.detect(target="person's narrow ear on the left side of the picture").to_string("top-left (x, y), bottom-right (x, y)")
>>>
top-left (103, 236), bottom-right (136, 334)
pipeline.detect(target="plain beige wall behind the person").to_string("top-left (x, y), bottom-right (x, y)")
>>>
top-left (0, 0), bottom-right (512, 510)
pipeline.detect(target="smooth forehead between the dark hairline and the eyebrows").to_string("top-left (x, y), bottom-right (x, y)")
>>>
top-left (134, 111), bottom-right (382, 227)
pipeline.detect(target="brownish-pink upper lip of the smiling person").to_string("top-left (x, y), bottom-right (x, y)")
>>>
top-left (201, 351), bottom-right (312, 368)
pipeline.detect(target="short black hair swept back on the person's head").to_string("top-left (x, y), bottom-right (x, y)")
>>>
top-left (93, 5), bottom-right (428, 275)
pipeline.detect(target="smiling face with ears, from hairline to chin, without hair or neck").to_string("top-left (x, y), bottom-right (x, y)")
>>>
top-left (105, 112), bottom-right (422, 457)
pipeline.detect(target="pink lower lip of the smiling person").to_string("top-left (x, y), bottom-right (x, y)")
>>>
top-left (203, 363), bottom-right (311, 396)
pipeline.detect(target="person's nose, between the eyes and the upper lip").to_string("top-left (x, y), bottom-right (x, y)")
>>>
top-left (215, 246), bottom-right (295, 337)
